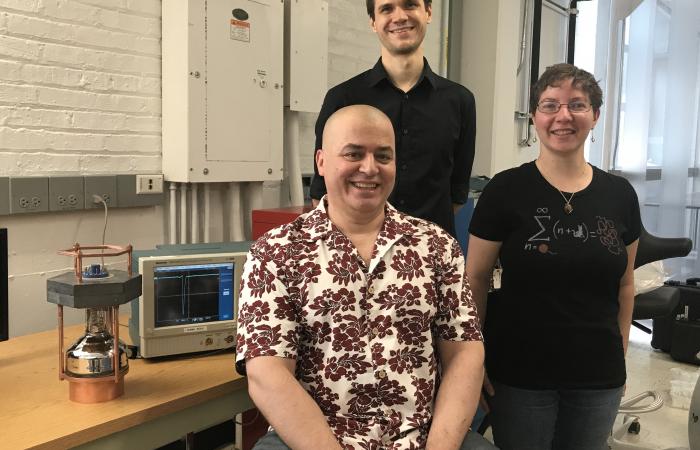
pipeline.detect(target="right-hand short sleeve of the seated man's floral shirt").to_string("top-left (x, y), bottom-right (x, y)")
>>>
top-left (435, 232), bottom-right (483, 341)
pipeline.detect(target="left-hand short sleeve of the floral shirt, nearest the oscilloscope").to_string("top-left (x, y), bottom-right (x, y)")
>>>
top-left (236, 235), bottom-right (298, 372)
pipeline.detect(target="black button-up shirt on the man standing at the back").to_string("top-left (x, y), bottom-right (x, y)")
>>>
top-left (311, 58), bottom-right (476, 237)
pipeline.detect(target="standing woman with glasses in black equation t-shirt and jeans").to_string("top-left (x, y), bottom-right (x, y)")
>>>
top-left (467, 64), bottom-right (641, 450)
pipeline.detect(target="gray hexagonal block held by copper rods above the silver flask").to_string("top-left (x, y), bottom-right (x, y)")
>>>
top-left (46, 270), bottom-right (141, 308)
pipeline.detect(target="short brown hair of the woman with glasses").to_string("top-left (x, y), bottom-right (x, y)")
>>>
top-left (530, 63), bottom-right (603, 114)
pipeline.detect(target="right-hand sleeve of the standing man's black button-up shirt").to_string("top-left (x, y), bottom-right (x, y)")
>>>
top-left (450, 89), bottom-right (476, 205)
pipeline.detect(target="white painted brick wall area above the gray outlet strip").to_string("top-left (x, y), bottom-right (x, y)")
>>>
top-left (0, 0), bottom-right (161, 176)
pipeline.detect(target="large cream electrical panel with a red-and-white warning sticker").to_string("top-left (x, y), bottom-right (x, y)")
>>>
top-left (162, 0), bottom-right (284, 182)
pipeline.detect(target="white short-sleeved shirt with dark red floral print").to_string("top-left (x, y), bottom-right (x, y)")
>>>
top-left (236, 199), bottom-right (482, 449)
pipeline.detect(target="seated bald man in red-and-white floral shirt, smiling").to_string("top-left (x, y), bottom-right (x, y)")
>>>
top-left (236, 105), bottom-right (494, 450)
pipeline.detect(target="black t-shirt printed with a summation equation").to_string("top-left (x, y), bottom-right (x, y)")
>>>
top-left (469, 161), bottom-right (641, 389)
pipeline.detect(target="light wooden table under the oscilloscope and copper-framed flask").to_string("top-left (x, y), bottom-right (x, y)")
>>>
top-left (0, 321), bottom-right (253, 449)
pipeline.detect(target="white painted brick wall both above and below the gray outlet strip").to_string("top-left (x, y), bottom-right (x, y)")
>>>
top-left (0, 0), bottom-right (164, 336)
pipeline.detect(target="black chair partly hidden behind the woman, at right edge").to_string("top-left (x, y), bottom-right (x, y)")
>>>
top-left (632, 225), bottom-right (693, 333)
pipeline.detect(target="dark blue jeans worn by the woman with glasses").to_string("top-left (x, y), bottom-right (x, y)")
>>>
top-left (490, 382), bottom-right (622, 450)
